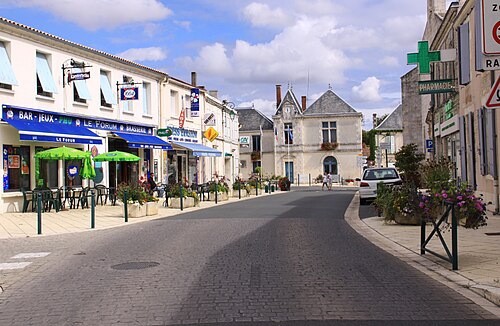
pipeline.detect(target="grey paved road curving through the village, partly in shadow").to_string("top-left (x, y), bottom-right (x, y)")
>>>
top-left (0, 188), bottom-right (500, 325)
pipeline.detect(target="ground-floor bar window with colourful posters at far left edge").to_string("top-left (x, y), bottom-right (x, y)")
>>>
top-left (2, 145), bottom-right (30, 191)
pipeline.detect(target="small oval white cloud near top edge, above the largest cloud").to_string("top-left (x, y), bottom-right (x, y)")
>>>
top-left (243, 2), bottom-right (291, 27)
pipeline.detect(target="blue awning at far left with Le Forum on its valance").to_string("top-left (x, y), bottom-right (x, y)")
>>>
top-left (4, 119), bottom-right (102, 144)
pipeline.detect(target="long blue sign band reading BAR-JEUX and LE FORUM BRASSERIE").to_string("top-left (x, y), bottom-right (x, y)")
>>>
top-left (2, 105), bottom-right (153, 135)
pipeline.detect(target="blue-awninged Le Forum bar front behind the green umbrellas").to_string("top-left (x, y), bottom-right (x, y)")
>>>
top-left (0, 105), bottom-right (171, 212)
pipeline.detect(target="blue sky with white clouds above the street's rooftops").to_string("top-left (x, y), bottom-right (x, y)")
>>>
top-left (0, 0), bottom-right (450, 130)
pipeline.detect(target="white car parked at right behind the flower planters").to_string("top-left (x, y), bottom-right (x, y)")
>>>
top-left (356, 168), bottom-right (402, 205)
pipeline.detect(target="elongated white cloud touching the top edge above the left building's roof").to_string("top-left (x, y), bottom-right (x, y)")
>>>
top-left (9, 0), bottom-right (172, 31)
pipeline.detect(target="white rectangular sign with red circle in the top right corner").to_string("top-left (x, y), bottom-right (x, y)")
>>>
top-left (481, 0), bottom-right (500, 54)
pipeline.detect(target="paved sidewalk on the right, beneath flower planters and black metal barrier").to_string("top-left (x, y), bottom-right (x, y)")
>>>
top-left (345, 194), bottom-right (500, 317)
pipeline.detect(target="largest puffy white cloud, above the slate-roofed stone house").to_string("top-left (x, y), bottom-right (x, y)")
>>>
top-left (178, 17), bottom-right (351, 83)
